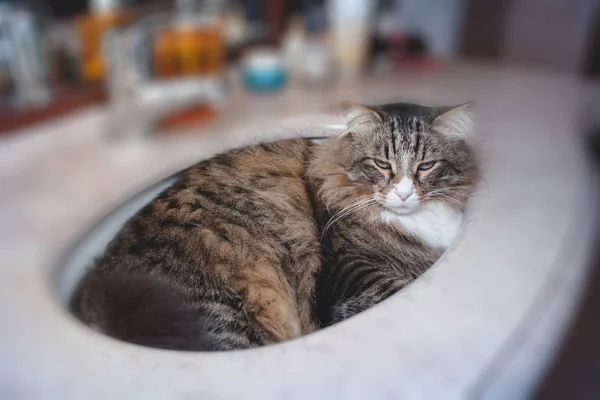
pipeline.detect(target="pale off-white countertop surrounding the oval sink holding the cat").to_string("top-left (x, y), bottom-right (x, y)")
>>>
top-left (0, 65), bottom-right (591, 398)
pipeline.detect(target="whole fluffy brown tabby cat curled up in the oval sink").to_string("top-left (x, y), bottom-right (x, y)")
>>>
top-left (74, 103), bottom-right (476, 350)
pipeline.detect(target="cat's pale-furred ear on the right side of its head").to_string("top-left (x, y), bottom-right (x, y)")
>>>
top-left (433, 101), bottom-right (475, 142)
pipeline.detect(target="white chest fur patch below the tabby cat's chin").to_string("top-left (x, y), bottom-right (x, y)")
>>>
top-left (381, 203), bottom-right (463, 249)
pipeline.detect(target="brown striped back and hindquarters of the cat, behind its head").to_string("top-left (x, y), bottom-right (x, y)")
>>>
top-left (74, 140), bottom-right (321, 350)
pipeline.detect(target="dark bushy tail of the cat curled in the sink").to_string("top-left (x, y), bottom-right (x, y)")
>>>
top-left (73, 270), bottom-right (214, 351)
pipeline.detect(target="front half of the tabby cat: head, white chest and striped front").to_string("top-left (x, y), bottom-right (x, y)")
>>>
top-left (308, 103), bottom-right (478, 326)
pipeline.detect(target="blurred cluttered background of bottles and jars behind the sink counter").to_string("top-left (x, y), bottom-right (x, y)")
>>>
top-left (0, 0), bottom-right (600, 135)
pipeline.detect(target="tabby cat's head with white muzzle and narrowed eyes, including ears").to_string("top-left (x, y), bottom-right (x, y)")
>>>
top-left (310, 102), bottom-right (477, 219)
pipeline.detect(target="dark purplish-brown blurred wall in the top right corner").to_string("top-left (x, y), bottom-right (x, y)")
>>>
top-left (461, 0), bottom-right (600, 74)
